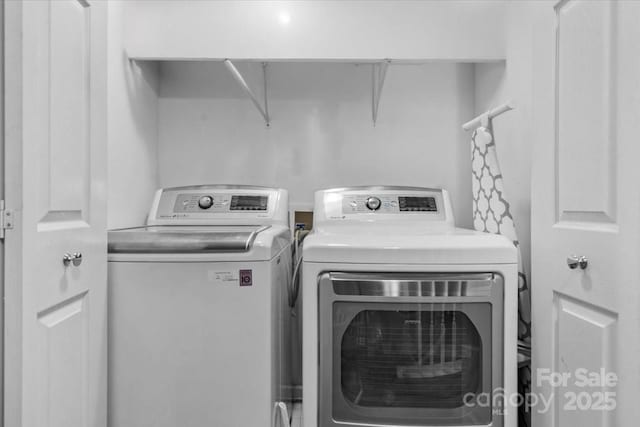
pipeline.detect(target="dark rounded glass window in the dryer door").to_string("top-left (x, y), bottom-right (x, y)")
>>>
top-left (337, 307), bottom-right (482, 409)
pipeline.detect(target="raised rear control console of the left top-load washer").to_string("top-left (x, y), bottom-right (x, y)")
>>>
top-left (147, 185), bottom-right (288, 226)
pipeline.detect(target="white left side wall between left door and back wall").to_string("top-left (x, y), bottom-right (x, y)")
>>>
top-left (107, 0), bottom-right (158, 228)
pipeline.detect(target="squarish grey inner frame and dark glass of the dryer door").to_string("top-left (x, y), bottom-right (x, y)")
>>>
top-left (332, 302), bottom-right (491, 425)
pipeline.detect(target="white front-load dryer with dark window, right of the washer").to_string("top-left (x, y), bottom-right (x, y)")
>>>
top-left (302, 187), bottom-right (518, 427)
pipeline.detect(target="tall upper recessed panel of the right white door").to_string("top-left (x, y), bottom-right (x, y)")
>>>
top-left (554, 0), bottom-right (618, 232)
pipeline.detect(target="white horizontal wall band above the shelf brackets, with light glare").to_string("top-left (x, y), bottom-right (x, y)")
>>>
top-left (125, 0), bottom-right (505, 61)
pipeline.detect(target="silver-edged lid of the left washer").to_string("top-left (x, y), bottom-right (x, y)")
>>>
top-left (108, 225), bottom-right (271, 253)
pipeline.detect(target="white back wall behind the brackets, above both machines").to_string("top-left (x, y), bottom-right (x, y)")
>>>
top-left (158, 62), bottom-right (474, 226)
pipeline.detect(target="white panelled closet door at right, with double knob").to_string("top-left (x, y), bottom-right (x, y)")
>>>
top-left (532, 0), bottom-right (640, 427)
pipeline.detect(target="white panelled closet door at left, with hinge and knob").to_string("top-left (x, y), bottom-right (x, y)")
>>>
top-left (4, 0), bottom-right (107, 427)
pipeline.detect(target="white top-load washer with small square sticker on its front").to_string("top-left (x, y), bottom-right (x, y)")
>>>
top-left (108, 185), bottom-right (291, 427)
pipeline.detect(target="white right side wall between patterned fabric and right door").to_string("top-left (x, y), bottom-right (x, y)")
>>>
top-left (475, 1), bottom-right (536, 278)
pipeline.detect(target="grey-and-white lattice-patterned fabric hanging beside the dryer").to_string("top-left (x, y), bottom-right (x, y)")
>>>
top-left (471, 121), bottom-right (531, 426)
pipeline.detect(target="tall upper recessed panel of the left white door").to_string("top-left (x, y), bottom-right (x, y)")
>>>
top-left (38, 0), bottom-right (91, 231)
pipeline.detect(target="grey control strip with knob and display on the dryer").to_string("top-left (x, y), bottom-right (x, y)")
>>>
top-left (342, 194), bottom-right (439, 214)
